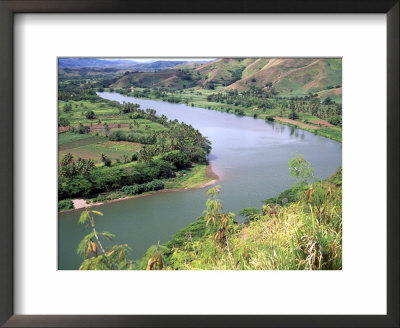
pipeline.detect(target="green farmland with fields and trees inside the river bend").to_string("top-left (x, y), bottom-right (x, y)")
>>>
top-left (58, 90), bottom-right (215, 210)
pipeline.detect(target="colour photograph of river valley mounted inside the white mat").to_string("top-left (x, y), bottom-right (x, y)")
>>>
top-left (54, 56), bottom-right (342, 270)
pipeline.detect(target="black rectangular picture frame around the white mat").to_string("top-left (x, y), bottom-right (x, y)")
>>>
top-left (0, 0), bottom-right (400, 327)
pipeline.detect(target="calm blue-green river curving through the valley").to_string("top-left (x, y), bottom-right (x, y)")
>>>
top-left (58, 92), bottom-right (342, 270)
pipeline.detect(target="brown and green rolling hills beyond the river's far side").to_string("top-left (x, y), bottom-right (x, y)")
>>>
top-left (112, 58), bottom-right (342, 97)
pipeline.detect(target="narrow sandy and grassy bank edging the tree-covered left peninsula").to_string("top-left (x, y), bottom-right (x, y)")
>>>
top-left (59, 164), bottom-right (219, 213)
